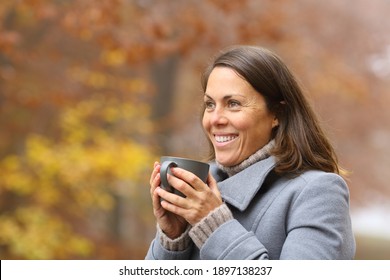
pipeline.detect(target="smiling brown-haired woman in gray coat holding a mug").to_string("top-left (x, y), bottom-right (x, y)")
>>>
top-left (146, 46), bottom-right (355, 259)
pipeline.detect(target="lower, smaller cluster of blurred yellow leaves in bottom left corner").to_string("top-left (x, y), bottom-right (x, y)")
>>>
top-left (0, 207), bottom-right (93, 259)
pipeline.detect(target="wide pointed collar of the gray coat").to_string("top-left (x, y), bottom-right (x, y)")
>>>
top-left (213, 156), bottom-right (276, 211)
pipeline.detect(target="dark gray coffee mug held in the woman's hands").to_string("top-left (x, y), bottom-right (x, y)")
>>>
top-left (160, 156), bottom-right (210, 197)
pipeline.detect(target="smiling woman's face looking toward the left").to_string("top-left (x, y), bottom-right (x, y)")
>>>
top-left (202, 67), bottom-right (278, 166)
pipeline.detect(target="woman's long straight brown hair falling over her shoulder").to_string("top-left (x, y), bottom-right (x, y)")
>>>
top-left (202, 46), bottom-right (340, 175)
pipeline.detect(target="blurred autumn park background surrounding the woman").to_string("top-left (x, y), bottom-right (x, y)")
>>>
top-left (0, 0), bottom-right (390, 259)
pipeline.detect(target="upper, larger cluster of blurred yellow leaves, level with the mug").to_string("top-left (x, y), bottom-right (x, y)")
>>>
top-left (1, 95), bottom-right (153, 202)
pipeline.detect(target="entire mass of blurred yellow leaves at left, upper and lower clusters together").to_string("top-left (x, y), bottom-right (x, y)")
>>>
top-left (0, 94), bottom-right (154, 259)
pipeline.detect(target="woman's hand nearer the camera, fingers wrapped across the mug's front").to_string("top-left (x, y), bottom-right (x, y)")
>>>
top-left (156, 167), bottom-right (223, 225)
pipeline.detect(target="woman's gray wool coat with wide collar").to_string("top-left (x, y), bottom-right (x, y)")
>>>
top-left (146, 157), bottom-right (355, 260)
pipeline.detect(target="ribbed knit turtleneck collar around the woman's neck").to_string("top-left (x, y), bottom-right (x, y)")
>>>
top-left (216, 140), bottom-right (275, 177)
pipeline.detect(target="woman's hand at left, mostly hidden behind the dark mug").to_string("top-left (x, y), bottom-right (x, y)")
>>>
top-left (150, 162), bottom-right (188, 239)
